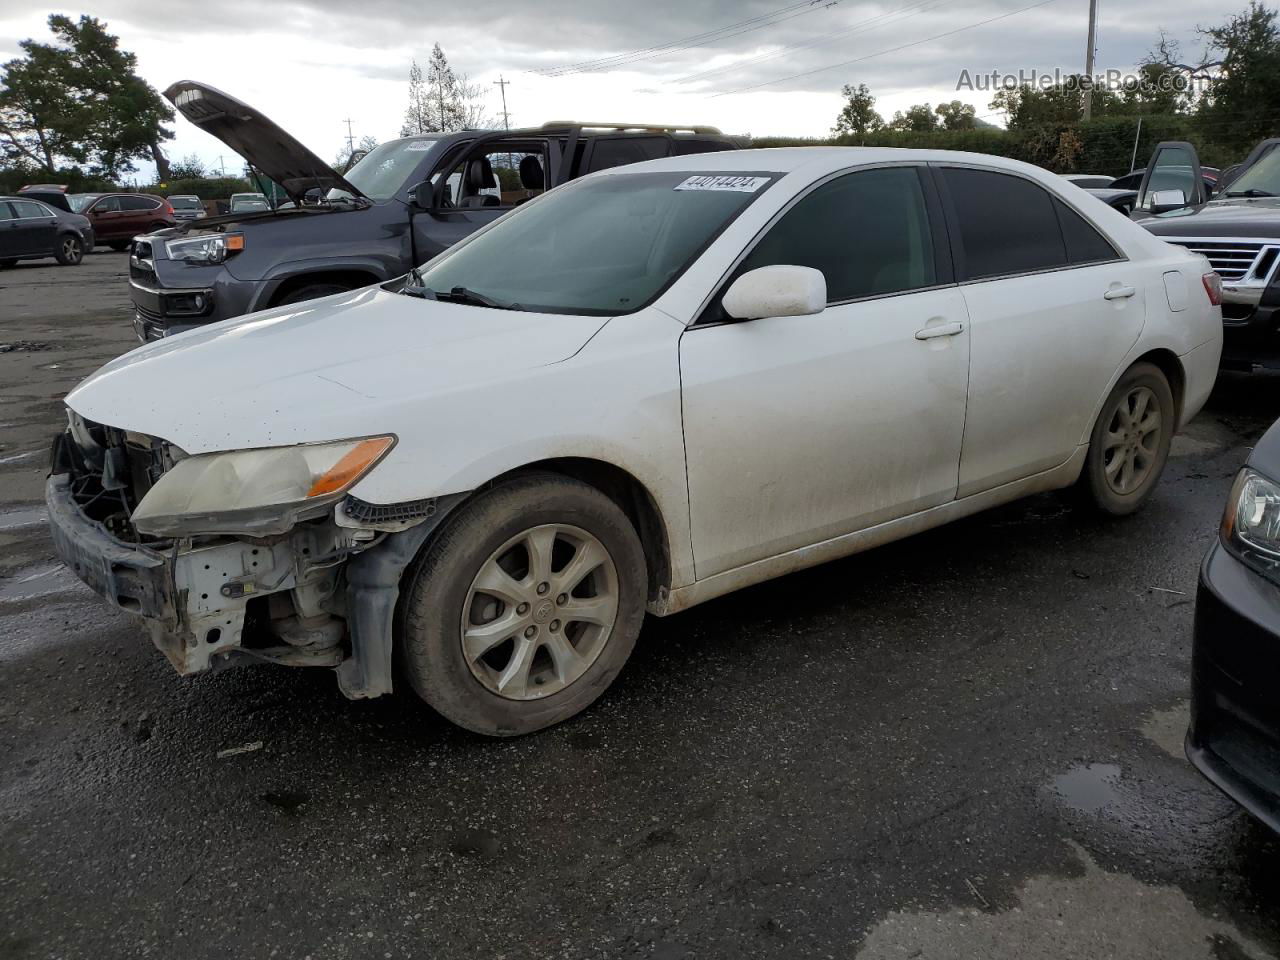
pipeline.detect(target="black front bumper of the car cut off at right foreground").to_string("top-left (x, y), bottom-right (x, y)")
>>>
top-left (1187, 543), bottom-right (1280, 832)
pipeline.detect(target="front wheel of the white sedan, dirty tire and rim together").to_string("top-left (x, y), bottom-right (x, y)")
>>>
top-left (398, 475), bottom-right (646, 736)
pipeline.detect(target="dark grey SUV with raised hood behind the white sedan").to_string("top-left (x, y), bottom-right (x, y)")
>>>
top-left (129, 81), bottom-right (745, 339)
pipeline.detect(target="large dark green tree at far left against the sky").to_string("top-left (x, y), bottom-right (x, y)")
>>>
top-left (0, 14), bottom-right (173, 180)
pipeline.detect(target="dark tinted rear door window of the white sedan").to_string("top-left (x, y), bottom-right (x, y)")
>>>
top-left (938, 166), bottom-right (1068, 280)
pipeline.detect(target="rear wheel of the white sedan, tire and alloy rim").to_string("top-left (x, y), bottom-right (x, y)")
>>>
top-left (1080, 364), bottom-right (1178, 516)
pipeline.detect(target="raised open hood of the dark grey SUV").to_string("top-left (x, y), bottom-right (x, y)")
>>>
top-left (164, 81), bottom-right (365, 204)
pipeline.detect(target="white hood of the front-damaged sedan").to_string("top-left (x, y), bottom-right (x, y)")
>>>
top-left (67, 287), bottom-right (608, 453)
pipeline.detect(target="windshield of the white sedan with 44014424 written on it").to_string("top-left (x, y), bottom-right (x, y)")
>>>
top-left (420, 170), bottom-right (776, 315)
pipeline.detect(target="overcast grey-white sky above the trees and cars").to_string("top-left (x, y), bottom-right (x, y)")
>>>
top-left (0, 0), bottom-right (1218, 175)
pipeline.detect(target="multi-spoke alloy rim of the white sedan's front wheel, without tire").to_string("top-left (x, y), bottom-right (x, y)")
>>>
top-left (461, 524), bottom-right (618, 700)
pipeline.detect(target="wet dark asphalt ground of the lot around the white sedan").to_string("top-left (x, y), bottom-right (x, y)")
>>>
top-left (0, 251), bottom-right (1280, 960)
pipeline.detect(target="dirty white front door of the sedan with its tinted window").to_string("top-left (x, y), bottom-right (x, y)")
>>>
top-left (680, 166), bottom-right (969, 579)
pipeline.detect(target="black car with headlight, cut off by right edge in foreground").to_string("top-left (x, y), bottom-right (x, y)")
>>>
top-left (1187, 426), bottom-right (1280, 832)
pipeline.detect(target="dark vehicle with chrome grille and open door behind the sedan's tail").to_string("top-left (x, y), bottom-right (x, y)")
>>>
top-left (1134, 140), bottom-right (1280, 370)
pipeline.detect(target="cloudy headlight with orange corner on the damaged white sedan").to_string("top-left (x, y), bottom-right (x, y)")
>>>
top-left (132, 436), bottom-right (396, 536)
